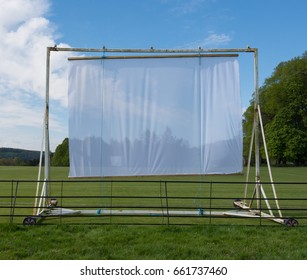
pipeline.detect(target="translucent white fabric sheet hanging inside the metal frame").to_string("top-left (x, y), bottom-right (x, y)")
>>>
top-left (68, 57), bottom-right (243, 177)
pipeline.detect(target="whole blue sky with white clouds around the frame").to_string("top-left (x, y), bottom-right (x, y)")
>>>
top-left (0, 0), bottom-right (307, 150)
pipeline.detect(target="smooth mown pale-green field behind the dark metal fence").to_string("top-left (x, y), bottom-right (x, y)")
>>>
top-left (0, 167), bottom-right (307, 225)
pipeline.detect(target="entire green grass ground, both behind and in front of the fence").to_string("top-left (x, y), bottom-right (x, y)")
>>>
top-left (0, 167), bottom-right (307, 259)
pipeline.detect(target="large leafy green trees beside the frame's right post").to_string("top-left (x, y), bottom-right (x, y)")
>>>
top-left (244, 52), bottom-right (307, 165)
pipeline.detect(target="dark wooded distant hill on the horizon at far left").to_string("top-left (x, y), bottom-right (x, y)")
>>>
top-left (0, 148), bottom-right (40, 165)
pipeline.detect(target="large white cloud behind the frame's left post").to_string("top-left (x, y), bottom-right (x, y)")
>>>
top-left (0, 0), bottom-right (67, 149)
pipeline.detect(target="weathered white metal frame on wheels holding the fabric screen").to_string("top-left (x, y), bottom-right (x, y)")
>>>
top-left (29, 46), bottom-right (297, 225)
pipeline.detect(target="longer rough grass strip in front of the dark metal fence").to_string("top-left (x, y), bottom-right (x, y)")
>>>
top-left (0, 224), bottom-right (307, 260)
